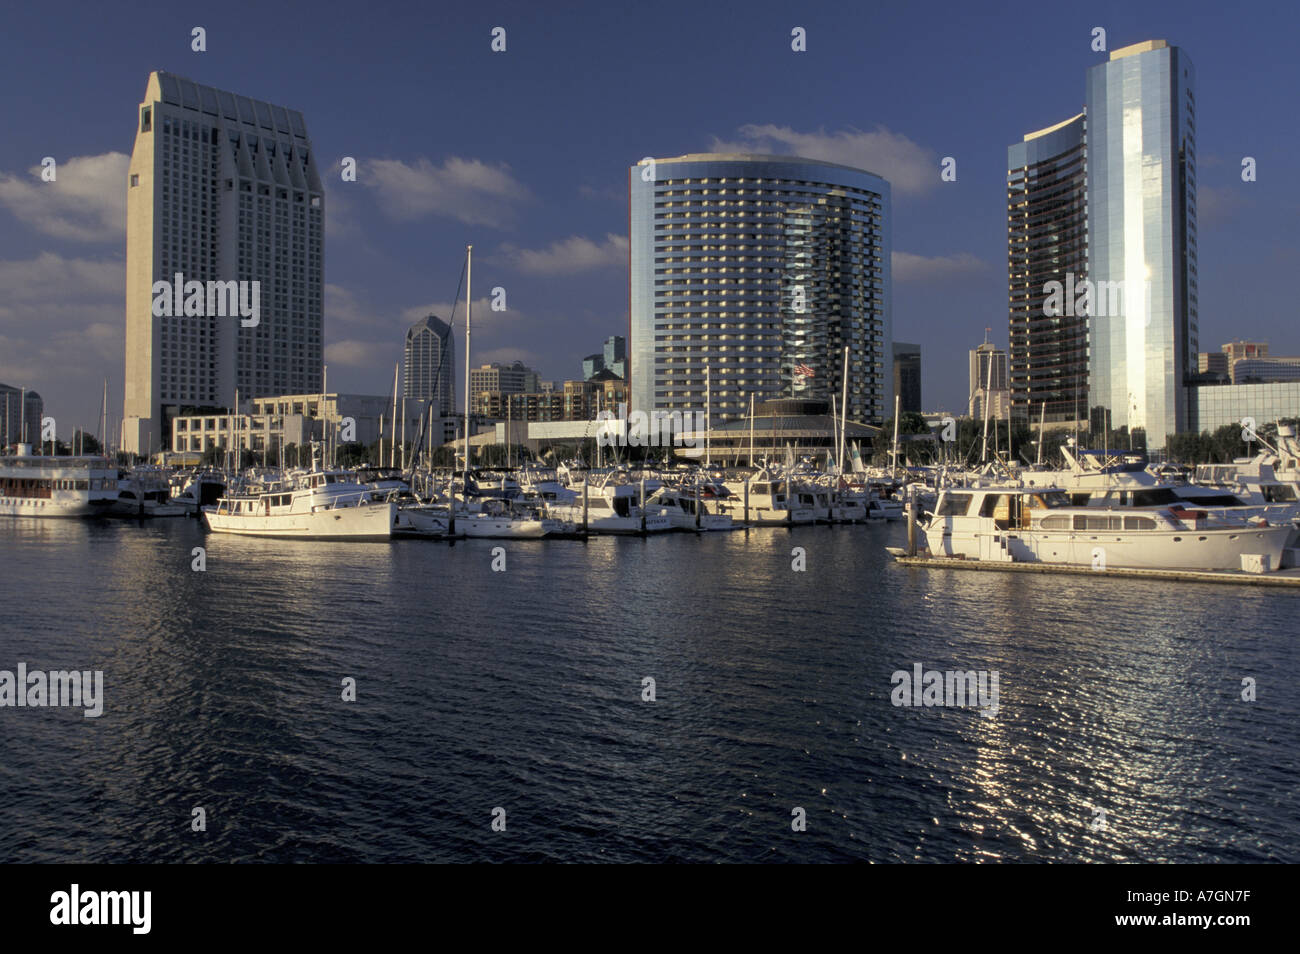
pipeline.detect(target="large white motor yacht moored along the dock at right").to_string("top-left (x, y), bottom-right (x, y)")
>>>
top-left (918, 486), bottom-right (1294, 571)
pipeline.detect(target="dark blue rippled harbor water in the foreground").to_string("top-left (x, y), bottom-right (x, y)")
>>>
top-left (0, 519), bottom-right (1300, 862)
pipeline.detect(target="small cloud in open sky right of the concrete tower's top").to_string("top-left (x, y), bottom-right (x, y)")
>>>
top-left (358, 156), bottom-right (529, 229)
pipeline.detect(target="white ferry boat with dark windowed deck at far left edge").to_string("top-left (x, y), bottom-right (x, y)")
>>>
top-left (0, 445), bottom-right (117, 517)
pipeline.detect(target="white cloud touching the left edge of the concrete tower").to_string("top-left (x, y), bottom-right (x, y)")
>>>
top-left (0, 152), bottom-right (130, 242)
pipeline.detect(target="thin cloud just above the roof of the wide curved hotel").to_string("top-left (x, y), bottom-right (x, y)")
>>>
top-left (710, 123), bottom-right (940, 195)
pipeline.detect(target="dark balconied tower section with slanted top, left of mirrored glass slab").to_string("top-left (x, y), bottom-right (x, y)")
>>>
top-left (1006, 113), bottom-right (1088, 421)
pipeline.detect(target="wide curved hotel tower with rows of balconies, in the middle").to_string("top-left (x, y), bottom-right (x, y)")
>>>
top-left (628, 153), bottom-right (893, 424)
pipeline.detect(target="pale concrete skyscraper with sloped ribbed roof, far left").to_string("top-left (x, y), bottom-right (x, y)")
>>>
top-left (122, 70), bottom-right (324, 454)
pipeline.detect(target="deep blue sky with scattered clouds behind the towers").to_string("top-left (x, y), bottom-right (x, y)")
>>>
top-left (0, 0), bottom-right (1300, 435)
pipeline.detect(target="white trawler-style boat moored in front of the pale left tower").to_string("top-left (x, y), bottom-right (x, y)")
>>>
top-left (203, 469), bottom-right (398, 539)
